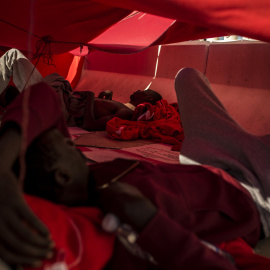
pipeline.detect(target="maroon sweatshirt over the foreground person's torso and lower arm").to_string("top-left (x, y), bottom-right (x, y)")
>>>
top-left (89, 159), bottom-right (264, 270)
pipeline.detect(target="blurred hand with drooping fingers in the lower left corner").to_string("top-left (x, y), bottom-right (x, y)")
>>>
top-left (0, 172), bottom-right (53, 266)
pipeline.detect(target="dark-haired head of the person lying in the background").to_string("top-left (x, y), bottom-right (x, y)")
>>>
top-left (129, 89), bottom-right (162, 106)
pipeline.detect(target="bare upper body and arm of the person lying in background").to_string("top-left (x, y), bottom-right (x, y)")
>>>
top-left (82, 92), bottom-right (133, 130)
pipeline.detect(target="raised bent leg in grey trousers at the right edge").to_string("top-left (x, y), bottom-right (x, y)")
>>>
top-left (175, 68), bottom-right (270, 235)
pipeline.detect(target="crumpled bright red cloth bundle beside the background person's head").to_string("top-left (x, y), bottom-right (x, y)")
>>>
top-left (106, 99), bottom-right (184, 151)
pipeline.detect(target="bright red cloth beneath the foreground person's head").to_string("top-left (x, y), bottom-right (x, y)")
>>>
top-left (25, 195), bottom-right (114, 270)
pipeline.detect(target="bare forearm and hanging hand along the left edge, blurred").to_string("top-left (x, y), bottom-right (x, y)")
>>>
top-left (0, 125), bottom-right (53, 266)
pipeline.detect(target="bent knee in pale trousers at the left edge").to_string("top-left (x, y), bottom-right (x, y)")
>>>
top-left (0, 49), bottom-right (43, 94)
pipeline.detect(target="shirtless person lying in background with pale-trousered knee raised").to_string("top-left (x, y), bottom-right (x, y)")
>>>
top-left (0, 49), bottom-right (162, 131)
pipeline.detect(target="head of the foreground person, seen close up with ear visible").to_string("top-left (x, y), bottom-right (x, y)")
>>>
top-left (24, 129), bottom-right (94, 206)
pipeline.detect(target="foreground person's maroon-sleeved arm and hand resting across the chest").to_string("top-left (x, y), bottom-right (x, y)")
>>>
top-left (99, 182), bottom-right (236, 270)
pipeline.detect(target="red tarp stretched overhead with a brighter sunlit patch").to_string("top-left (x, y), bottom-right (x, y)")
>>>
top-left (0, 0), bottom-right (270, 53)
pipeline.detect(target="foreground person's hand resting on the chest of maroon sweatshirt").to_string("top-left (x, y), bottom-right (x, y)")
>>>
top-left (98, 182), bottom-right (157, 232)
